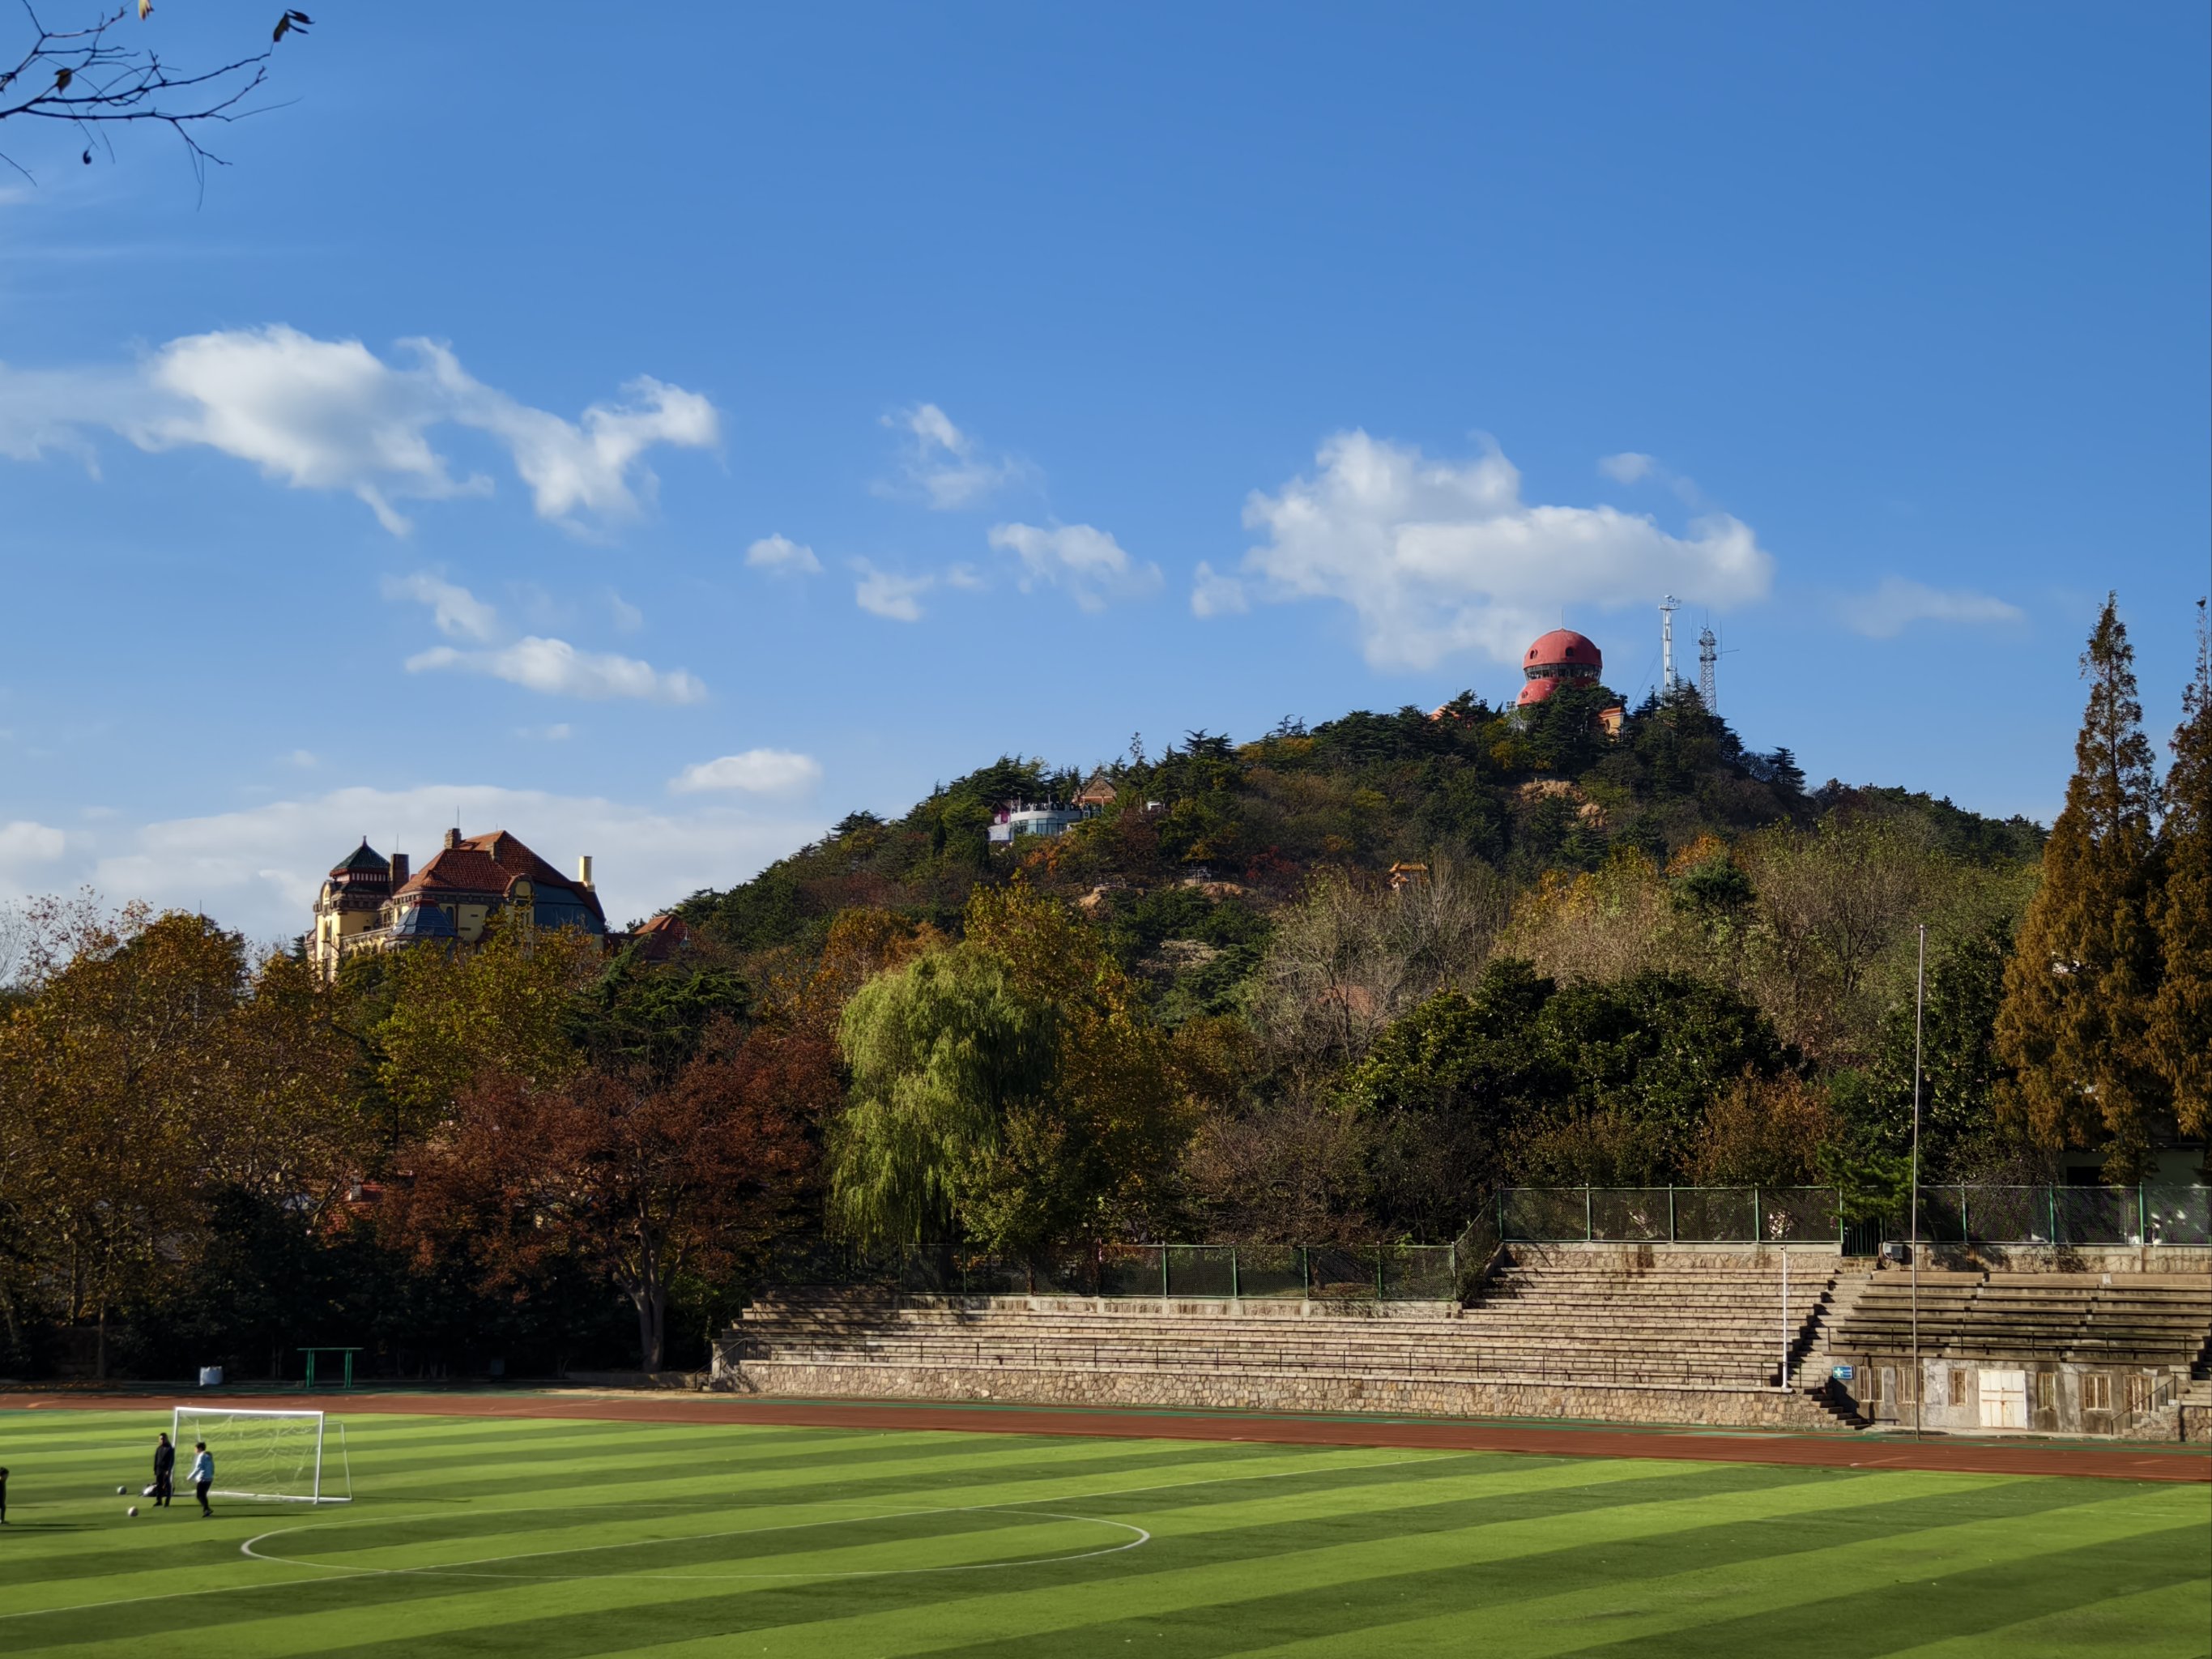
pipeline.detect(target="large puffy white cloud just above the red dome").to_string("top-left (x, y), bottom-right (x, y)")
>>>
top-left (1221, 431), bottom-right (1774, 668)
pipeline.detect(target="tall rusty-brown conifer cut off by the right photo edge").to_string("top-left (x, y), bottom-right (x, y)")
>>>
top-left (2150, 599), bottom-right (2212, 1135)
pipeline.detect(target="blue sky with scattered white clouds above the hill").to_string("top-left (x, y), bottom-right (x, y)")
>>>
top-left (0, 0), bottom-right (2212, 938)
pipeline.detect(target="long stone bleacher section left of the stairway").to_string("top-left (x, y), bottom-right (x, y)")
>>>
top-left (717, 1252), bottom-right (1838, 1427)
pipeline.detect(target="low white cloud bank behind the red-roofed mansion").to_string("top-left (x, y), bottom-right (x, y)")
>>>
top-left (0, 783), bottom-right (827, 940)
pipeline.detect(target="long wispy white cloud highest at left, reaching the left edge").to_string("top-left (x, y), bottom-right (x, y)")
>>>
top-left (0, 323), bottom-right (721, 535)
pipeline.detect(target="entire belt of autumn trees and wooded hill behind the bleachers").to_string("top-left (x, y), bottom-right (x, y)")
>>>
top-left (0, 606), bottom-right (2212, 1375)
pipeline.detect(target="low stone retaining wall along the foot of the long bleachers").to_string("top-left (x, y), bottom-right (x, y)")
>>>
top-left (710, 1336), bottom-right (1838, 1429)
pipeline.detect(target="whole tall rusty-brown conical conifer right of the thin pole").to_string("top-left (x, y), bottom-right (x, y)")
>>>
top-left (1997, 595), bottom-right (2167, 1181)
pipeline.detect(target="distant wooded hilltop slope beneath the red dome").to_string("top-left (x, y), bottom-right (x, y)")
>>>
top-left (681, 686), bottom-right (2044, 1057)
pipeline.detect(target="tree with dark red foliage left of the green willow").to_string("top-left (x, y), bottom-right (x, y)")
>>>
top-left (396, 1024), bottom-right (838, 1371)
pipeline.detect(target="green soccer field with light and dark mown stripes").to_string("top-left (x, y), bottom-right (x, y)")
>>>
top-left (0, 1411), bottom-right (2212, 1659)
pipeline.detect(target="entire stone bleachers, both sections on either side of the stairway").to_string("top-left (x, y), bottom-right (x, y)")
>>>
top-left (714, 1245), bottom-right (2212, 1431)
